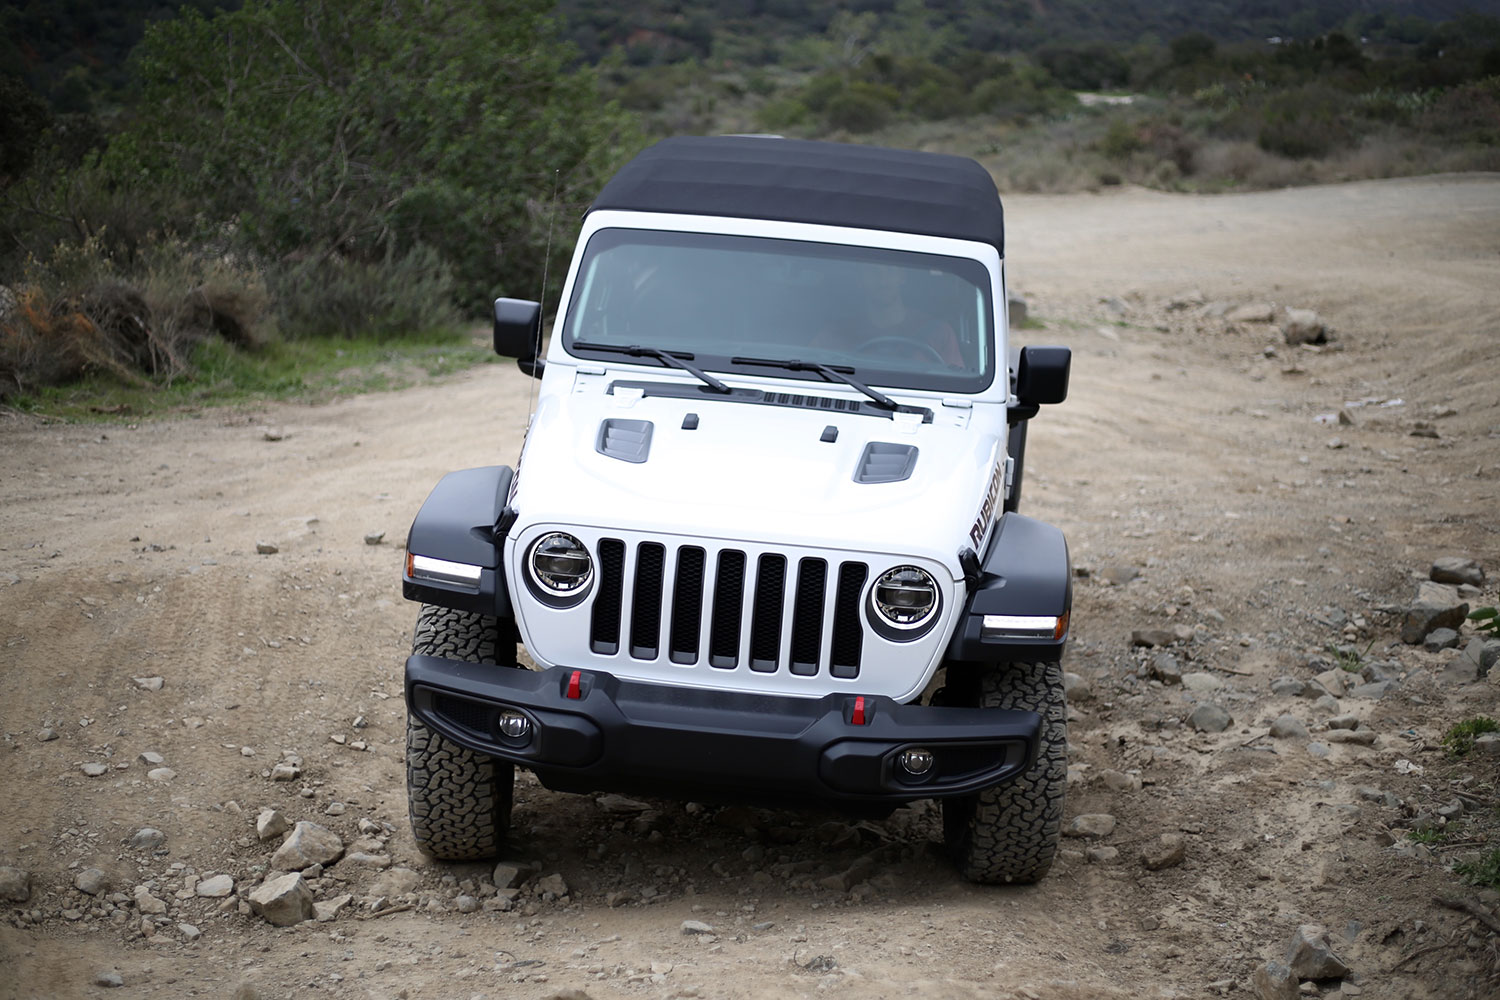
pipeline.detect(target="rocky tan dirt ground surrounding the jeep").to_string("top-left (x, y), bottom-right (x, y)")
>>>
top-left (0, 175), bottom-right (1500, 1000)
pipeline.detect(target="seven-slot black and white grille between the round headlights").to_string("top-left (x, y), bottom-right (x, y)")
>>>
top-left (590, 538), bottom-right (870, 678)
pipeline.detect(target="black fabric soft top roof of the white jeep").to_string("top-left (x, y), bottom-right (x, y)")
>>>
top-left (593, 135), bottom-right (1005, 256)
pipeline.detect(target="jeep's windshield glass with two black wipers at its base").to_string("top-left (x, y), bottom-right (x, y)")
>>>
top-left (563, 229), bottom-right (995, 393)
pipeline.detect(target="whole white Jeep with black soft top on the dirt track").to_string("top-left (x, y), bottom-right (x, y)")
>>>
top-left (404, 136), bottom-right (1073, 882)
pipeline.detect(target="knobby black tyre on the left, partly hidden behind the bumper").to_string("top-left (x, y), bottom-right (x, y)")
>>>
top-left (407, 604), bottom-right (516, 861)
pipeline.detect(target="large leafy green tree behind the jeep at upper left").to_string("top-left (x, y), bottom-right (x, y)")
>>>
top-left (115, 0), bottom-right (632, 303)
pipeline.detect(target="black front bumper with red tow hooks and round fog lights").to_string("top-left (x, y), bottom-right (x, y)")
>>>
top-left (407, 657), bottom-right (1041, 805)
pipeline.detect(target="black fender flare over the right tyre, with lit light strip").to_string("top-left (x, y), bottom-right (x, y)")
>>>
top-left (947, 511), bottom-right (1073, 663)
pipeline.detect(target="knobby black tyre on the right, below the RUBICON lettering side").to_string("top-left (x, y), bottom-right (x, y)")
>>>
top-left (942, 663), bottom-right (1068, 885)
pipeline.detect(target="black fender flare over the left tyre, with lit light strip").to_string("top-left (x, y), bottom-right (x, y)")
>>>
top-left (401, 465), bottom-right (515, 619)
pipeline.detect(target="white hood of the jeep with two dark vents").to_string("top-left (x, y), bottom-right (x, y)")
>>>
top-left (512, 367), bottom-right (1004, 579)
